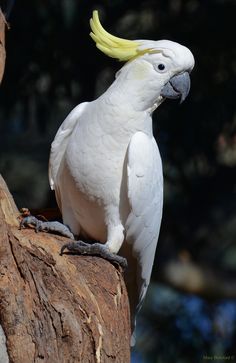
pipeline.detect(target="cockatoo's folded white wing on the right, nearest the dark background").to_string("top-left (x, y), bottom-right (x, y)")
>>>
top-left (125, 132), bottom-right (163, 324)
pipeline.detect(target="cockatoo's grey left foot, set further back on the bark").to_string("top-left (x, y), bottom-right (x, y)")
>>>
top-left (20, 215), bottom-right (74, 239)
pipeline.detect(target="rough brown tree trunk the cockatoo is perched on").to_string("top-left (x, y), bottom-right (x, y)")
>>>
top-left (0, 178), bottom-right (130, 363)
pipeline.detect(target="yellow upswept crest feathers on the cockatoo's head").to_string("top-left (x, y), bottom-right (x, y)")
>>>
top-left (89, 10), bottom-right (159, 61)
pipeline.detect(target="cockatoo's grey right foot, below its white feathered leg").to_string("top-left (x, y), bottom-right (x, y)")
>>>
top-left (61, 241), bottom-right (127, 269)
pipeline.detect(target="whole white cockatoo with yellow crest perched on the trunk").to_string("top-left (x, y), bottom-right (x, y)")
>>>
top-left (23, 11), bottom-right (194, 344)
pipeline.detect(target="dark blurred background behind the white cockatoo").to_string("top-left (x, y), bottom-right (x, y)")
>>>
top-left (0, 0), bottom-right (236, 363)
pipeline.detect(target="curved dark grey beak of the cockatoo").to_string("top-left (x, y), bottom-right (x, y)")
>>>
top-left (161, 72), bottom-right (191, 103)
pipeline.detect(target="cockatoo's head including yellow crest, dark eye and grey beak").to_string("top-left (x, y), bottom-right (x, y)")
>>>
top-left (90, 10), bottom-right (194, 111)
